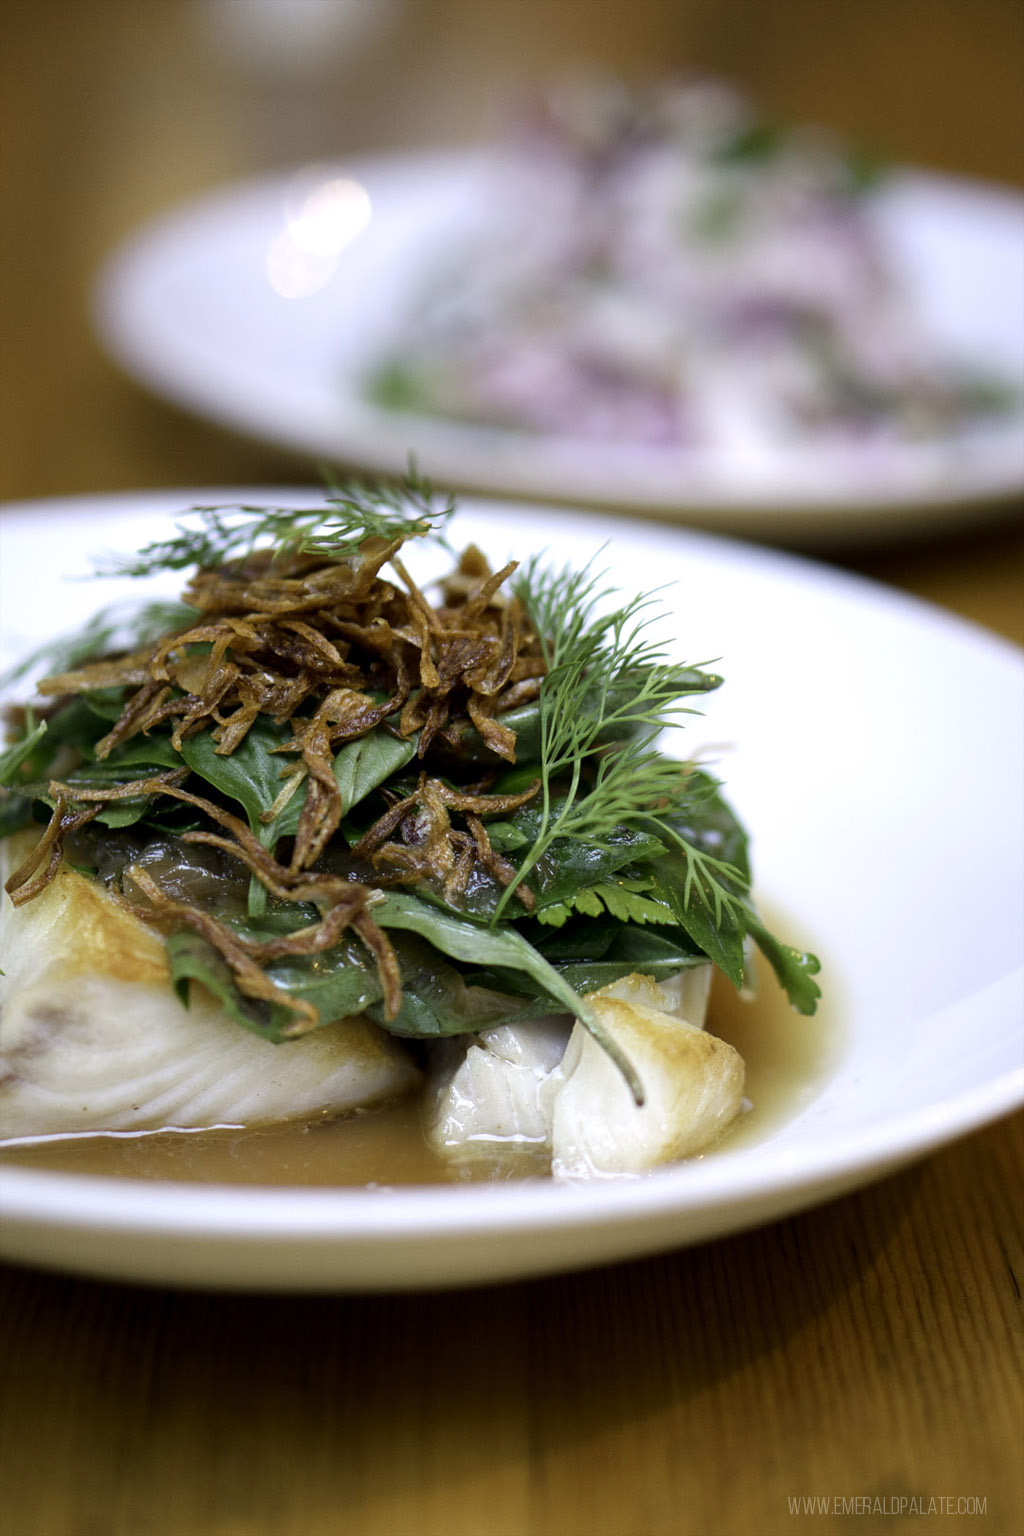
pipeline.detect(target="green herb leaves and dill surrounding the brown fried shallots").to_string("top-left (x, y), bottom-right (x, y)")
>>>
top-left (0, 479), bottom-right (818, 1101)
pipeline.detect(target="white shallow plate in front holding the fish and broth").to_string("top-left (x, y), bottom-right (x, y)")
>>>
top-left (0, 490), bottom-right (1024, 1290)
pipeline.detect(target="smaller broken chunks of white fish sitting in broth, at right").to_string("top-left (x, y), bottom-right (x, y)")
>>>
top-left (427, 965), bottom-right (743, 1180)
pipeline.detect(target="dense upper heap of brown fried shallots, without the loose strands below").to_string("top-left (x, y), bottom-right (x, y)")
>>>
top-left (40, 538), bottom-right (545, 774)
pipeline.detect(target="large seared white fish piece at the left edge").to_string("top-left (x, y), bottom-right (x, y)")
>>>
top-left (0, 865), bottom-right (419, 1140)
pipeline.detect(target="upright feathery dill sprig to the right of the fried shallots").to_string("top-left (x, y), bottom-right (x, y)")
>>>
top-left (496, 559), bottom-right (748, 923)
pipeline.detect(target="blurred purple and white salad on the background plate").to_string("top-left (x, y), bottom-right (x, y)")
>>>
top-left (364, 81), bottom-right (1019, 456)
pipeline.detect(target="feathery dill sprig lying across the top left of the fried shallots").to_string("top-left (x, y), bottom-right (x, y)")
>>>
top-left (95, 464), bottom-right (454, 576)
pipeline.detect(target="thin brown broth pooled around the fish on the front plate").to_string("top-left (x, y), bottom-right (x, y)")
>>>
top-left (0, 958), bottom-right (838, 1187)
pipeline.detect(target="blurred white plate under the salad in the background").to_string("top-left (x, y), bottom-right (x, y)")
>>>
top-left (95, 152), bottom-right (1024, 544)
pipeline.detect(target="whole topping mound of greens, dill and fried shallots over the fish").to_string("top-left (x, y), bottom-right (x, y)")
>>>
top-left (0, 481), bottom-right (818, 1097)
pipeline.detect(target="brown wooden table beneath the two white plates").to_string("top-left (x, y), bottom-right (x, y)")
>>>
top-left (0, 0), bottom-right (1024, 1536)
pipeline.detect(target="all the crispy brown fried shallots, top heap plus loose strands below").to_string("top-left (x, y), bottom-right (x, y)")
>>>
top-left (16, 536), bottom-right (545, 1034)
